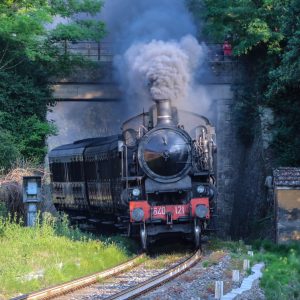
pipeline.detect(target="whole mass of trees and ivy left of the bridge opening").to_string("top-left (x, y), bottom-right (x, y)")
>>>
top-left (0, 0), bottom-right (104, 170)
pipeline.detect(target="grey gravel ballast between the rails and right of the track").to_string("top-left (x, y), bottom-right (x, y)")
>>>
top-left (55, 251), bottom-right (265, 300)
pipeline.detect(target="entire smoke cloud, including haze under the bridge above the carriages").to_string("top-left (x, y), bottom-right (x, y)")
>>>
top-left (48, 0), bottom-right (211, 148)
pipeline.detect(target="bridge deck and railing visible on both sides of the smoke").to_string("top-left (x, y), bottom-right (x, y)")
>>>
top-left (53, 42), bottom-right (242, 101)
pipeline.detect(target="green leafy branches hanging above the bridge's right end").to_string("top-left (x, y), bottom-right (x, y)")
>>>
top-left (190, 0), bottom-right (287, 55)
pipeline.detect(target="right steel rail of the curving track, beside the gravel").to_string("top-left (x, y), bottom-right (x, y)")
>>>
top-left (105, 250), bottom-right (201, 300)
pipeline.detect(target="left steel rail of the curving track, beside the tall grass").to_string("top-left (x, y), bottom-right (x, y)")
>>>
top-left (11, 254), bottom-right (144, 300)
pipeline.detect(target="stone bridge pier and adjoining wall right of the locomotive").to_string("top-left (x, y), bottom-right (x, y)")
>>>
top-left (206, 82), bottom-right (272, 238)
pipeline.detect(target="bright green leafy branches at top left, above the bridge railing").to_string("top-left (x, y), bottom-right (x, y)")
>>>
top-left (0, 0), bottom-right (104, 64)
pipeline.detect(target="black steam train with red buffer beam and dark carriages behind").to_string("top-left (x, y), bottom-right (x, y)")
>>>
top-left (49, 99), bottom-right (216, 250)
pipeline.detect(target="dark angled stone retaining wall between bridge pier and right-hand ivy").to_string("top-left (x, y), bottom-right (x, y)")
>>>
top-left (230, 120), bottom-right (269, 238)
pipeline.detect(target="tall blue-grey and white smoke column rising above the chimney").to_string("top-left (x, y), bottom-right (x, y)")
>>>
top-left (103, 0), bottom-right (210, 117)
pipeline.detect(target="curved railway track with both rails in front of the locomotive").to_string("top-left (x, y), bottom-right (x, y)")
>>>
top-left (13, 250), bottom-right (201, 300)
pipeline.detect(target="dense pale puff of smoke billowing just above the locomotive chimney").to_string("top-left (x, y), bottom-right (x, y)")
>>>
top-left (119, 35), bottom-right (205, 102)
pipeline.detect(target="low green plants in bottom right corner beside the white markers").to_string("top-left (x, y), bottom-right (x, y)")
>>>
top-left (209, 239), bottom-right (300, 300)
